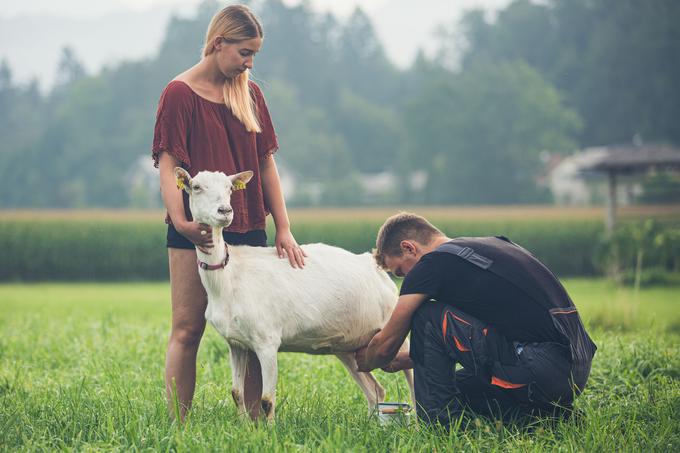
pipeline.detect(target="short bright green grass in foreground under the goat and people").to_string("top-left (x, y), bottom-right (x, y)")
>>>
top-left (0, 280), bottom-right (680, 451)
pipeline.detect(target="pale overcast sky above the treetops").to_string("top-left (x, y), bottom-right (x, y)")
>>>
top-left (0, 0), bottom-right (509, 88)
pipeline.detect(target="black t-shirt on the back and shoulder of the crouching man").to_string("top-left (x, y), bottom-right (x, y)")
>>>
top-left (401, 251), bottom-right (563, 342)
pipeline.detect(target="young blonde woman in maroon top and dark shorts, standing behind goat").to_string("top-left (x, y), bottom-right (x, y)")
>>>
top-left (152, 5), bottom-right (305, 419)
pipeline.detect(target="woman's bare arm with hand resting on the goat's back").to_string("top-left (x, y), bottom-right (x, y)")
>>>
top-left (260, 154), bottom-right (307, 268)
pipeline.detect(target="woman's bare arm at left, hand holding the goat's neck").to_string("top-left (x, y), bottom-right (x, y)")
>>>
top-left (158, 152), bottom-right (213, 254)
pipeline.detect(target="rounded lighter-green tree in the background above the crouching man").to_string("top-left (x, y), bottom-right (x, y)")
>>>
top-left (405, 61), bottom-right (580, 204)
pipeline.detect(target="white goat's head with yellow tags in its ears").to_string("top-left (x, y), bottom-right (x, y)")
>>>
top-left (175, 167), bottom-right (253, 227)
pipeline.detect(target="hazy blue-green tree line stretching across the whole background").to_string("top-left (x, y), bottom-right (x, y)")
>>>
top-left (0, 0), bottom-right (680, 208)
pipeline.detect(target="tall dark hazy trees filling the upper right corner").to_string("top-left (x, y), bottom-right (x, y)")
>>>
top-left (462, 0), bottom-right (680, 146)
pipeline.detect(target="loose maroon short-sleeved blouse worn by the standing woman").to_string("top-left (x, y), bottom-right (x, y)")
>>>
top-left (152, 80), bottom-right (279, 233)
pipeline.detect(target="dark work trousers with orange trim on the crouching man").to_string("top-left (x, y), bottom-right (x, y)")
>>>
top-left (410, 301), bottom-right (573, 426)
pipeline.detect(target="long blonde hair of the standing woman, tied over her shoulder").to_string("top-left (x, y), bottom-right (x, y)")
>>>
top-left (203, 5), bottom-right (264, 132)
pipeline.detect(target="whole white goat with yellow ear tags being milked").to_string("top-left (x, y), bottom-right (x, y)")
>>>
top-left (175, 167), bottom-right (414, 420)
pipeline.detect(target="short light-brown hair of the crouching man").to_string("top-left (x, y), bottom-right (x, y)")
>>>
top-left (373, 212), bottom-right (444, 269)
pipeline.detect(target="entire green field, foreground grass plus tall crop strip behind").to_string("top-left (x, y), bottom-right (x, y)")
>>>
top-left (0, 206), bottom-right (680, 452)
